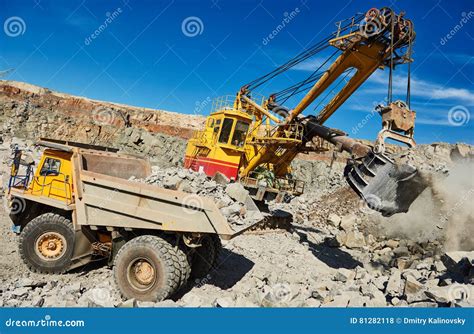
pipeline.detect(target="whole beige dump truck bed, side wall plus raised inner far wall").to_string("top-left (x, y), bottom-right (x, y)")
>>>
top-left (69, 150), bottom-right (241, 239)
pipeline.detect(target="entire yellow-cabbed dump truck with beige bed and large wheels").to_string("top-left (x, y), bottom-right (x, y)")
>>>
top-left (6, 139), bottom-right (248, 301)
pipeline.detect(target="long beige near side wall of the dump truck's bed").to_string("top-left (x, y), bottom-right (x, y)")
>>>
top-left (76, 171), bottom-right (234, 239)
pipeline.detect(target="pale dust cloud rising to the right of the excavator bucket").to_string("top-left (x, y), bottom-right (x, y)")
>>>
top-left (377, 161), bottom-right (474, 251)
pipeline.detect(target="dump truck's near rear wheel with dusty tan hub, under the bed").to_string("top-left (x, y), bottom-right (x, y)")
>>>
top-left (114, 235), bottom-right (181, 302)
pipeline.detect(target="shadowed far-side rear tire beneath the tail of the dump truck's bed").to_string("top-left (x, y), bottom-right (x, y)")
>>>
top-left (191, 235), bottom-right (222, 278)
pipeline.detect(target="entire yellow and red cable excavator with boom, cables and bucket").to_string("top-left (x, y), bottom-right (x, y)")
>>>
top-left (184, 7), bottom-right (426, 216)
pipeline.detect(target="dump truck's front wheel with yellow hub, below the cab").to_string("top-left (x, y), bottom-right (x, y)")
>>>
top-left (19, 213), bottom-right (74, 274)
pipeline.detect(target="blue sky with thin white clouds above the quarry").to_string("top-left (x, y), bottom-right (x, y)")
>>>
top-left (0, 0), bottom-right (474, 144)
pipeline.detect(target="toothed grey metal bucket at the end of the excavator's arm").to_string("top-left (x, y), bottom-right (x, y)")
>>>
top-left (345, 152), bottom-right (428, 217)
